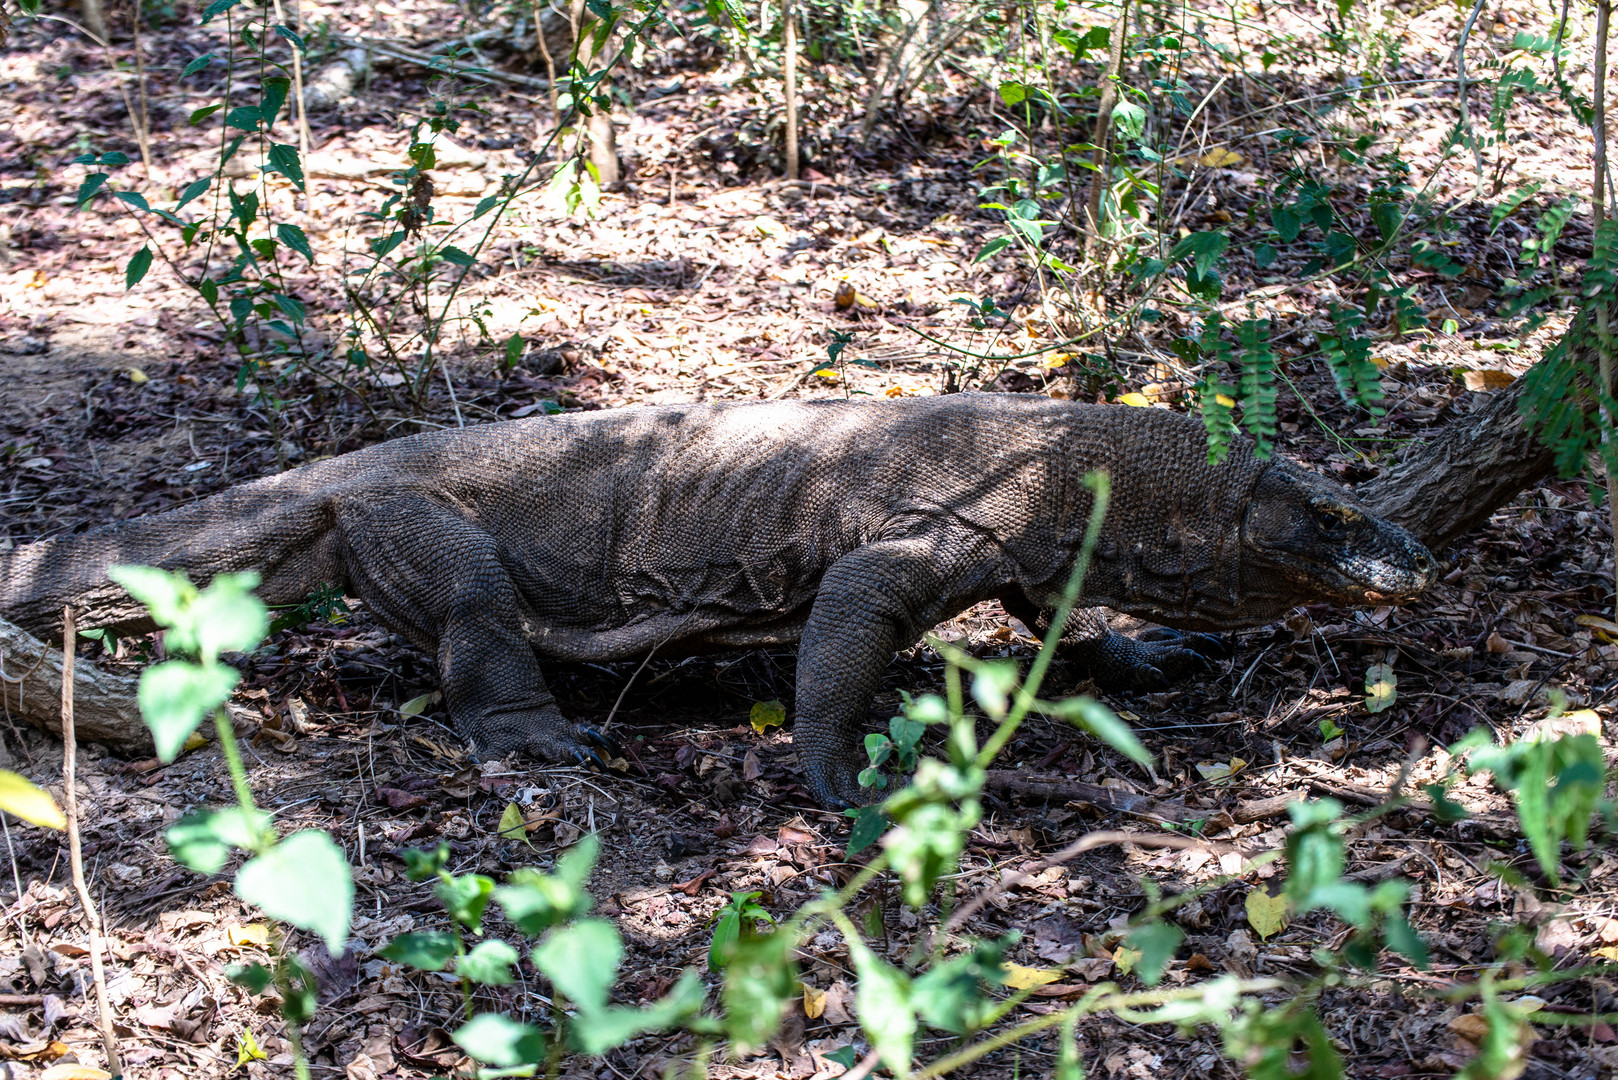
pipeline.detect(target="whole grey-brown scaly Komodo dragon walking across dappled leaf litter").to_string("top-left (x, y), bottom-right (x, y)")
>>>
top-left (0, 393), bottom-right (1434, 805)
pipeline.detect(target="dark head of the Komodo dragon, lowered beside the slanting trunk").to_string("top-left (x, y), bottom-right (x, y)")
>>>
top-left (1241, 461), bottom-right (1438, 607)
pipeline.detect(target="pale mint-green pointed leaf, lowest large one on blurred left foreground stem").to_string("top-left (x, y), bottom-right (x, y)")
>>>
top-left (236, 829), bottom-right (354, 957)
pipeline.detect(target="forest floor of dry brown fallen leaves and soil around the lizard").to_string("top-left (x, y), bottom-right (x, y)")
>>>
top-left (0, 0), bottom-right (1618, 1080)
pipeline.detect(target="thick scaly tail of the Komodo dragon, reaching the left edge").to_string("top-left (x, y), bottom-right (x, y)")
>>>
top-left (0, 470), bottom-right (348, 636)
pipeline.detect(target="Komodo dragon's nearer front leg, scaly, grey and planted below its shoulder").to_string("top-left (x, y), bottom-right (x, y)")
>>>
top-left (793, 536), bottom-right (1005, 806)
